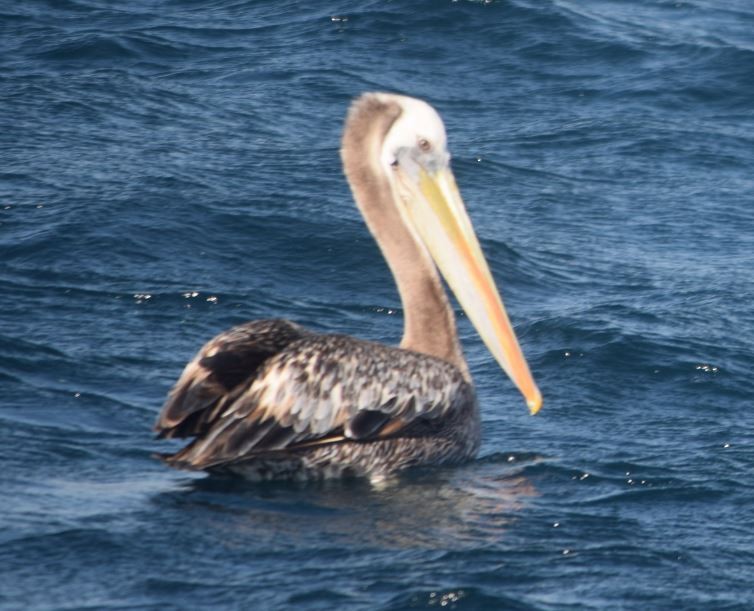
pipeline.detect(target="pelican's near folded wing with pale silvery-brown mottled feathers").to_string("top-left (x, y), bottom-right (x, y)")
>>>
top-left (160, 334), bottom-right (474, 469)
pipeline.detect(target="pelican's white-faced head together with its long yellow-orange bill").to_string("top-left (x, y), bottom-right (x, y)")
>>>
top-left (376, 94), bottom-right (542, 413)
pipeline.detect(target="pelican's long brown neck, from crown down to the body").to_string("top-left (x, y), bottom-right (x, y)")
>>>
top-left (341, 94), bottom-right (468, 376)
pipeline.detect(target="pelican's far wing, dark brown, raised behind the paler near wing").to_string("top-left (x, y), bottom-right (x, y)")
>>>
top-left (154, 320), bottom-right (308, 438)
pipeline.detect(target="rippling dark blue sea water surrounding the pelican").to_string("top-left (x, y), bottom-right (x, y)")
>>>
top-left (0, 0), bottom-right (754, 610)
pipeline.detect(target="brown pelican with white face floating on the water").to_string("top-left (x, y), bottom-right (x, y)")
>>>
top-left (155, 93), bottom-right (542, 481)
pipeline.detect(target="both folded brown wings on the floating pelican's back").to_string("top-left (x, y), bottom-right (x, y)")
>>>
top-left (156, 321), bottom-right (474, 469)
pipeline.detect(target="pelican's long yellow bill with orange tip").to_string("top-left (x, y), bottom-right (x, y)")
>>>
top-left (402, 167), bottom-right (542, 414)
